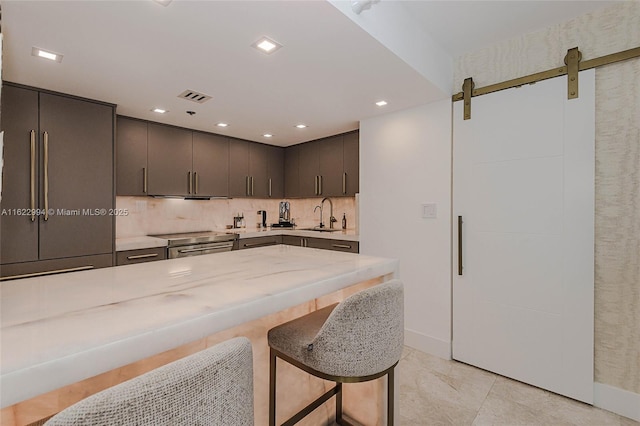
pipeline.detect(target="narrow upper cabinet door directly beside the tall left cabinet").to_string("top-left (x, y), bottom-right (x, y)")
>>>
top-left (116, 116), bottom-right (148, 195)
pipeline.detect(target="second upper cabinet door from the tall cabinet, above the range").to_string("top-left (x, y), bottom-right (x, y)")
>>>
top-left (147, 123), bottom-right (194, 197)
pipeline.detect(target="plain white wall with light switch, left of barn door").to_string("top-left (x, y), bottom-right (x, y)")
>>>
top-left (359, 99), bottom-right (451, 358)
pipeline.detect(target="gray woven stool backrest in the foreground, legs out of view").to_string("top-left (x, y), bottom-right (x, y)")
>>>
top-left (45, 337), bottom-right (253, 426)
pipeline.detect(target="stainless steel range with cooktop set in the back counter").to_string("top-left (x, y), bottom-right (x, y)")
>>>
top-left (150, 231), bottom-right (238, 259)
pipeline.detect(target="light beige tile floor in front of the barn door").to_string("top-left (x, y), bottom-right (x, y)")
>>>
top-left (396, 347), bottom-right (640, 426)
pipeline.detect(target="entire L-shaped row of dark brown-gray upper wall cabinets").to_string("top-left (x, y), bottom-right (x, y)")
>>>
top-left (116, 117), bottom-right (359, 198)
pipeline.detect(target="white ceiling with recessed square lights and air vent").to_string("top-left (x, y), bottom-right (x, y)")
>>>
top-left (2, 0), bottom-right (609, 146)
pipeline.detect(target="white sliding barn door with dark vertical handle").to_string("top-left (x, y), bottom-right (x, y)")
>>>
top-left (453, 70), bottom-right (595, 403)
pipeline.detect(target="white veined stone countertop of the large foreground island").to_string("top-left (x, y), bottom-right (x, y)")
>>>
top-left (0, 245), bottom-right (398, 407)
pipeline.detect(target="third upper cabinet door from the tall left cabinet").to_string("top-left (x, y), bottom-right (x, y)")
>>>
top-left (193, 132), bottom-right (229, 197)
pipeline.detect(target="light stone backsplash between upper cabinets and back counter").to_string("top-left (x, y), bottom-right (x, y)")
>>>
top-left (116, 197), bottom-right (357, 238)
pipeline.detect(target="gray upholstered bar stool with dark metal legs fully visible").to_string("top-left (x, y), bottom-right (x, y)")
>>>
top-left (268, 280), bottom-right (404, 426)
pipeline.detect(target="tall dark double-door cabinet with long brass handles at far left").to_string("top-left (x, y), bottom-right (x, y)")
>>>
top-left (0, 83), bottom-right (114, 277)
